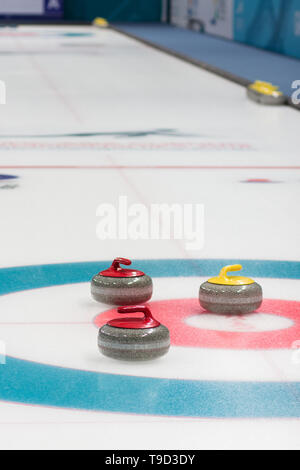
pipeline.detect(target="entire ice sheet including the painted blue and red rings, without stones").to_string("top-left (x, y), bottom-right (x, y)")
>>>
top-left (0, 26), bottom-right (300, 449)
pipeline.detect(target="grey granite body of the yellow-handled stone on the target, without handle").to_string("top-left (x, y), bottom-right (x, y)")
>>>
top-left (199, 282), bottom-right (263, 315)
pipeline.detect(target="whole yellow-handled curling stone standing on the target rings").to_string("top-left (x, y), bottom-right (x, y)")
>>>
top-left (199, 264), bottom-right (263, 315)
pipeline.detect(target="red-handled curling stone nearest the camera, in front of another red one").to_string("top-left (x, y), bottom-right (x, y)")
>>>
top-left (98, 305), bottom-right (170, 361)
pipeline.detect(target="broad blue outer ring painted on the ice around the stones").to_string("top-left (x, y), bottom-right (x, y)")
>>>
top-left (0, 259), bottom-right (300, 418)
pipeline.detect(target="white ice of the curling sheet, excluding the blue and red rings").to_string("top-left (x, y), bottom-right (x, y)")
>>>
top-left (0, 27), bottom-right (300, 449)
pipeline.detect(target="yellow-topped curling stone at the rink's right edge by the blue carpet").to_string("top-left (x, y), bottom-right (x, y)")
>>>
top-left (247, 80), bottom-right (286, 106)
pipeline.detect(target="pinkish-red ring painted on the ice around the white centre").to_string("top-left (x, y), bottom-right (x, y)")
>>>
top-left (95, 299), bottom-right (300, 349)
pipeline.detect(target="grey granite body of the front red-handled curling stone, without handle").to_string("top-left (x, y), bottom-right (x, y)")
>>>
top-left (98, 325), bottom-right (170, 361)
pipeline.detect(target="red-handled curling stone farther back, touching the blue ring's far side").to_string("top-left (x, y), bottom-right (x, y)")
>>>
top-left (91, 258), bottom-right (153, 306)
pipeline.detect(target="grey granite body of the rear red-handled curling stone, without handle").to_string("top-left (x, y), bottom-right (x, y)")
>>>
top-left (91, 274), bottom-right (153, 305)
